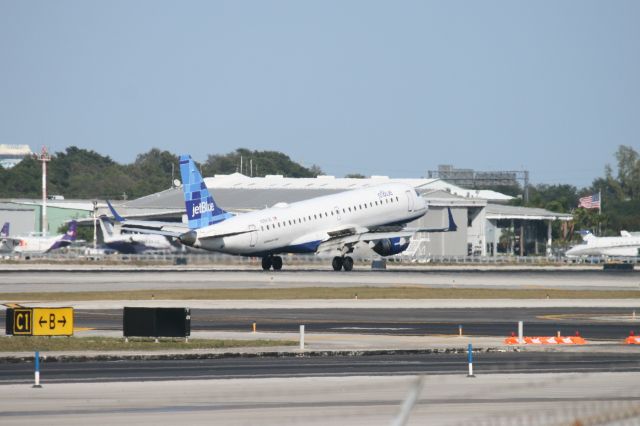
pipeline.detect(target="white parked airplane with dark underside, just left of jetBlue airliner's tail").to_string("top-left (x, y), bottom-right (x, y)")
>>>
top-left (98, 213), bottom-right (176, 254)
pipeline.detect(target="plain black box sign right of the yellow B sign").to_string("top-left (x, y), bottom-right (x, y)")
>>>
top-left (122, 307), bottom-right (191, 337)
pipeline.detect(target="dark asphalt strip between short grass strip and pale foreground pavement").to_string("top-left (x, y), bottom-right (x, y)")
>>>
top-left (0, 352), bottom-right (640, 384)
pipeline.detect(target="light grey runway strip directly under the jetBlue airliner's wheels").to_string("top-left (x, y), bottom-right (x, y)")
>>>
top-left (0, 269), bottom-right (640, 293)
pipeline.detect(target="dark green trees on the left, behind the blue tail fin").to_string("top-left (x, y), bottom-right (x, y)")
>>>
top-left (0, 146), bottom-right (322, 199)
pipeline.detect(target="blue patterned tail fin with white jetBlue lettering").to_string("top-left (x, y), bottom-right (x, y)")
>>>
top-left (180, 155), bottom-right (231, 229)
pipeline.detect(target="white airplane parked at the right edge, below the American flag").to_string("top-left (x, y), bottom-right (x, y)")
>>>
top-left (565, 231), bottom-right (640, 257)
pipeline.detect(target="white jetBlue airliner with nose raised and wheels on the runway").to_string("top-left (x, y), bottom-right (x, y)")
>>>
top-left (112, 155), bottom-right (457, 271)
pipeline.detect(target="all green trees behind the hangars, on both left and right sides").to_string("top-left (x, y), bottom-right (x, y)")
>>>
top-left (0, 145), bottom-right (640, 238)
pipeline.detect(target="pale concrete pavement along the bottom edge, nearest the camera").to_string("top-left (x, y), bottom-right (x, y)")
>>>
top-left (0, 372), bottom-right (640, 426)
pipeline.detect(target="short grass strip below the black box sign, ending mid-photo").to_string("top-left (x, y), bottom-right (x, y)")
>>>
top-left (0, 336), bottom-right (298, 352)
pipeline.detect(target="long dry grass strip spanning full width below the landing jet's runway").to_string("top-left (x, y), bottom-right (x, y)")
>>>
top-left (0, 286), bottom-right (640, 302)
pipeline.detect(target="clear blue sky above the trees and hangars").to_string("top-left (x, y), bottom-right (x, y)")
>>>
top-left (0, 0), bottom-right (640, 186)
